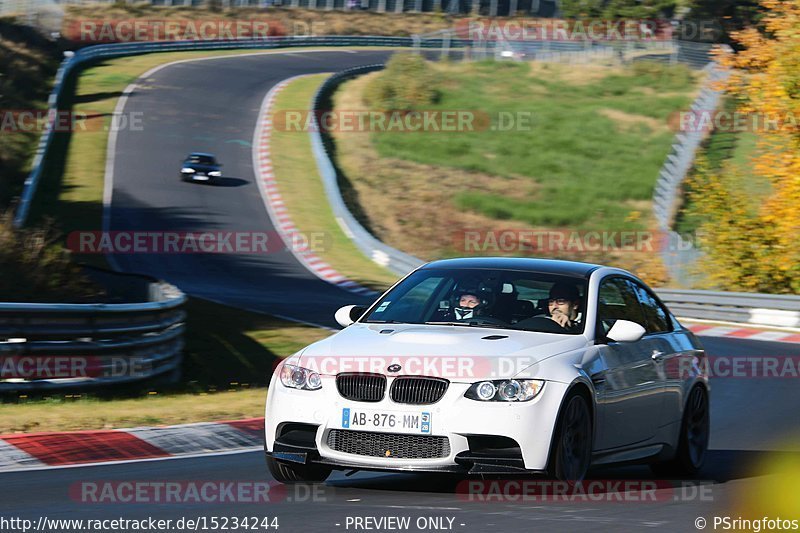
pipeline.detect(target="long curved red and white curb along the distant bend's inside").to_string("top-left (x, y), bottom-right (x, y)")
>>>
top-left (253, 75), bottom-right (378, 296)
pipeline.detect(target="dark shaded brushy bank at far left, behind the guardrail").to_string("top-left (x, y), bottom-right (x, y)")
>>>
top-left (0, 18), bottom-right (110, 302)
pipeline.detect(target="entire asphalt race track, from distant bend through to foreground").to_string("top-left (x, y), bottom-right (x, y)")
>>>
top-left (0, 47), bottom-right (800, 532)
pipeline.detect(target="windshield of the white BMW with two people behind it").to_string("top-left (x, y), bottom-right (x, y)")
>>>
top-left (362, 269), bottom-right (586, 335)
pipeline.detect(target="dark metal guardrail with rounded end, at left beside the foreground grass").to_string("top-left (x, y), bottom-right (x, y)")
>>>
top-left (0, 275), bottom-right (186, 392)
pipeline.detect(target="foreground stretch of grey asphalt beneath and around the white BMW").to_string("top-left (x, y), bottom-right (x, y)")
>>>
top-left (0, 338), bottom-right (800, 532)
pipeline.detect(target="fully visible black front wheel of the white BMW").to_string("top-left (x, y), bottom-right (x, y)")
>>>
top-left (547, 392), bottom-right (592, 483)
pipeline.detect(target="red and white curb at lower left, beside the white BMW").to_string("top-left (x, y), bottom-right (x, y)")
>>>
top-left (0, 418), bottom-right (264, 472)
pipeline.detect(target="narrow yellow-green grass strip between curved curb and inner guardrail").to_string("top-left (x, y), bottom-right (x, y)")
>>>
top-left (270, 74), bottom-right (397, 290)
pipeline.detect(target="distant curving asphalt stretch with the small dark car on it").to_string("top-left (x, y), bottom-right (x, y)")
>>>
top-left (109, 49), bottom-right (396, 325)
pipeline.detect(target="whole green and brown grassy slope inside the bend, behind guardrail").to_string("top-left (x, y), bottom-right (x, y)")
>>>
top-left (334, 58), bottom-right (699, 280)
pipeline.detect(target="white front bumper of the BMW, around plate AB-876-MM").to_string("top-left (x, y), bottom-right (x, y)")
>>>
top-left (265, 376), bottom-right (567, 474)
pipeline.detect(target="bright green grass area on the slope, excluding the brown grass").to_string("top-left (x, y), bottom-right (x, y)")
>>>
top-left (372, 62), bottom-right (697, 229)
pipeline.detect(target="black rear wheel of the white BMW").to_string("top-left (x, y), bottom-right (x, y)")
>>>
top-left (650, 385), bottom-right (711, 476)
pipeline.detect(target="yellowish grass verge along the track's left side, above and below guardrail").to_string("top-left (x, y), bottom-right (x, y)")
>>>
top-left (0, 47), bottom-right (344, 432)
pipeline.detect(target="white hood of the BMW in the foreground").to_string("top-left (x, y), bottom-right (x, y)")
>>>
top-left (292, 323), bottom-right (587, 382)
